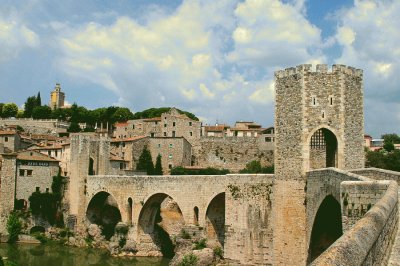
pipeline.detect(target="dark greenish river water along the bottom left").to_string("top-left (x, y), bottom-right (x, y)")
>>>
top-left (0, 243), bottom-right (169, 266)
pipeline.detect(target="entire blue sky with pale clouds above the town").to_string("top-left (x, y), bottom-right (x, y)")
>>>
top-left (0, 0), bottom-right (400, 137)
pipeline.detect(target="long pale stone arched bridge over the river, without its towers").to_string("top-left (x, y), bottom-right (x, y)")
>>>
top-left (75, 168), bottom-right (400, 265)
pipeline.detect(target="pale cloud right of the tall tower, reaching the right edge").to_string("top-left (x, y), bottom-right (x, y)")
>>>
top-left (336, 0), bottom-right (400, 135)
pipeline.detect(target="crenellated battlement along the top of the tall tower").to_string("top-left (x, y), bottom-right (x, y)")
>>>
top-left (275, 64), bottom-right (363, 78)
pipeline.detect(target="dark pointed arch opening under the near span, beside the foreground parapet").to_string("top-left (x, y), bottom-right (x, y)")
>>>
top-left (308, 195), bottom-right (343, 263)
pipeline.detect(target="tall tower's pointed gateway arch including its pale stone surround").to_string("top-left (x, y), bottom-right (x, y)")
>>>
top-left (304, 125), bottom-right (343, 170)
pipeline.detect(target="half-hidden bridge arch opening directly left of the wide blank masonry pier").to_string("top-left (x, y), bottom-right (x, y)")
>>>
top-left (205, 192), bottom-right (225, 247)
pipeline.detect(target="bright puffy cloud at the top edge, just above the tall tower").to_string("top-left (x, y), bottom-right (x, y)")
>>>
top-left (228, 0), bottom-right (322, 67)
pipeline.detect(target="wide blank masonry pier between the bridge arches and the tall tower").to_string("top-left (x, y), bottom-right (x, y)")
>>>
top-left (225, 175), bottom-right (273, 265)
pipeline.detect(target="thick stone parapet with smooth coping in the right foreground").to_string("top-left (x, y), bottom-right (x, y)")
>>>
top-left (311, 181), bottom-right (398, 266)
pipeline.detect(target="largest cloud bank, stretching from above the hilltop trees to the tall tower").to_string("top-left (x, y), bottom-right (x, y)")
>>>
top-left (55, 0), bottom-right (324, 126)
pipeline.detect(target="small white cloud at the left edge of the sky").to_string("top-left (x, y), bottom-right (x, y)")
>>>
top-left (0, 17), bottom-right (40, 62)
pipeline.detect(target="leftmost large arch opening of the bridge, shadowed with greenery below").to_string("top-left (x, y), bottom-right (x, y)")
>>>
top-left (86, 191), bottom-right (121, 240)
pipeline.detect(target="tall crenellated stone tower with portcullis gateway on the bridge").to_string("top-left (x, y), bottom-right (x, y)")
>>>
top-left (274, 65), bottom-right (364, 265)
